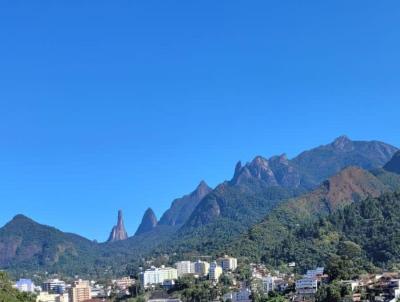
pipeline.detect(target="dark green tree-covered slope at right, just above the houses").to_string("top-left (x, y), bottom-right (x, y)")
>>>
top-left (233, 193), bottom-right (400, 279)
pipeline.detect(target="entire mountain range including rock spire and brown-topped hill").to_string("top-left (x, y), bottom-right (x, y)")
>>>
top-left (0, 136), bottom-right (400, 275)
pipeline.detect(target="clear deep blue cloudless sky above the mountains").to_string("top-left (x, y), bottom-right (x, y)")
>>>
top-left (0, 0), bottom-right (400, 240)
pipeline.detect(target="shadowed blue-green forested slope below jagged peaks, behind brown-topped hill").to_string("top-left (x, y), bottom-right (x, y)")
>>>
top-left (159, 182), bottom-right (302, 258)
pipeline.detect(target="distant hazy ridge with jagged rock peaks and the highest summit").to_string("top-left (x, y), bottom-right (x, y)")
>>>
top-left (231, 136), bottom-right (397, 189)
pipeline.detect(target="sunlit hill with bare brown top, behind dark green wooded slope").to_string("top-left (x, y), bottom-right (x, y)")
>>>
top-left (230, 167), bottom-right (400, 268)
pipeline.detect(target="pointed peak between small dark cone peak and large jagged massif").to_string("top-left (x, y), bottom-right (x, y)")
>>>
top-left (158, 181), bottom-right (212, 226)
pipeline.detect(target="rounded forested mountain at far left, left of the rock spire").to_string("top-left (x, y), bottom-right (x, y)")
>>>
top-left (0, 215), bottom-right (97, 274)
